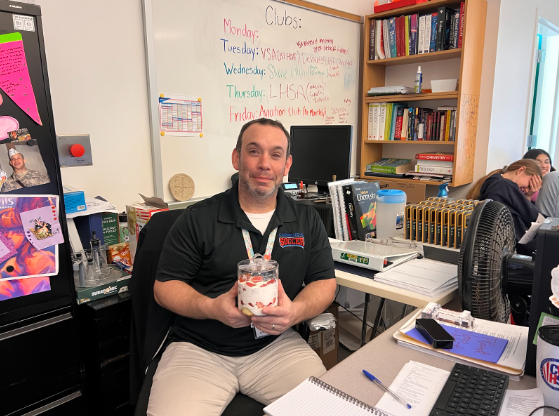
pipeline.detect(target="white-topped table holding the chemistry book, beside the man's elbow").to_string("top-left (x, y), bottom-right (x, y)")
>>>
top-left (336, 270), bottom-right (458, 346)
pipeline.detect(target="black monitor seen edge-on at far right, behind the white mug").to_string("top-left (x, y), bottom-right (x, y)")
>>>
top-left (525, 218), bottom-right (559, 376)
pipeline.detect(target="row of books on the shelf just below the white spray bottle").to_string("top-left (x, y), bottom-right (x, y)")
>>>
top-left (367, 102), bottom-right (456, 141)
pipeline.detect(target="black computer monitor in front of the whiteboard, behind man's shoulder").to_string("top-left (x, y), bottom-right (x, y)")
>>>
top-left (289, 125), bottom-right (352, 194)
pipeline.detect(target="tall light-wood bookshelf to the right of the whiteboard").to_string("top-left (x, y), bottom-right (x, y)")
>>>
top-left (360, 0), bottom-right (487, 186)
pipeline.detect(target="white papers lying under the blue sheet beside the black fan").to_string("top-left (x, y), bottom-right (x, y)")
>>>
top-left (394, 310), bottom-right (528, 374)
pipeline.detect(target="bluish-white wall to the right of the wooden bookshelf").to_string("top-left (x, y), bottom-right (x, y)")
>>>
top-left (486, 0), bottom-right (559, 171)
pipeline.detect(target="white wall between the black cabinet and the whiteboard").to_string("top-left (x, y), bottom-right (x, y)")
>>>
top-left (34, 0), bottom-right (153, 211)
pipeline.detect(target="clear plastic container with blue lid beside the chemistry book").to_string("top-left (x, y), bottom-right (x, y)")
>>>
top-left (377, 189), bottom-right (406, 239)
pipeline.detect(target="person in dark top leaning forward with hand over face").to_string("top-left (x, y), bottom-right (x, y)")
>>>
top-left (468, 159), bottom-right (542, 255)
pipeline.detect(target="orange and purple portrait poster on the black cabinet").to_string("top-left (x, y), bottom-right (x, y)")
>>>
top-left (0, 195), bottom-right (62, 282)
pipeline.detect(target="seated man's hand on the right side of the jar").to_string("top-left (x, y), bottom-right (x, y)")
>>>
top-left (251, 280), bottom-right (298, 335)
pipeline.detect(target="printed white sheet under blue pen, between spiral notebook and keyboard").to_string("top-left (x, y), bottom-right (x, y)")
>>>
top-left (375, 361), bottom-right (450, 416)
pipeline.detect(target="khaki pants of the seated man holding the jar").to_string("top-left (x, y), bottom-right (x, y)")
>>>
top-left (148, 329), bottom-right (326, 416)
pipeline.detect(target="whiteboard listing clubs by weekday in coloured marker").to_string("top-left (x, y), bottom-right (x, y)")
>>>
top-left (144, 0), bottom-right (362, 201)
